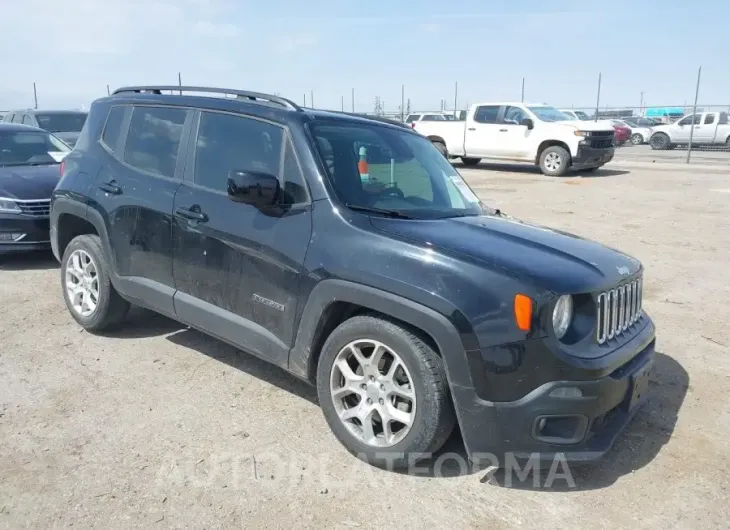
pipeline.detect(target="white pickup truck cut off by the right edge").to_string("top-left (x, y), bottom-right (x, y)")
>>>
top-left (649, 112), bottom-right (730, 150)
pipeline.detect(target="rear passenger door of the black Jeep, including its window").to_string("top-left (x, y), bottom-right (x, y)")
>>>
top-left (91, 105), bottom-right (193, 316)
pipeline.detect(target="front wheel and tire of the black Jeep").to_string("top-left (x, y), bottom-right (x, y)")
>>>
top-left (317, 315), bottom-right (456, 468)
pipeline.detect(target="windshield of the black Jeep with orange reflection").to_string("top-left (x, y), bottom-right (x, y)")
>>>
top-left (311, 121), bottom-right (484, 219)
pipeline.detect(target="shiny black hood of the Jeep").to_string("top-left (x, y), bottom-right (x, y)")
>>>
top-left (371, 211), bottom-right (641, 294)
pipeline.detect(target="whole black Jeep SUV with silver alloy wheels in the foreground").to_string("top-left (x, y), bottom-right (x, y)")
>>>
top-left (51, 86), bottom-right (655, 467)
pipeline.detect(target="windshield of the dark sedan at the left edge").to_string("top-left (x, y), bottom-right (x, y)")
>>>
top-left (0, 131), bottom-right (71, 167)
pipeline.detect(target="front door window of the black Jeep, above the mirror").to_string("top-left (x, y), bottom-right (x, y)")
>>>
top-left (195, 112), bottom-right (284, 192)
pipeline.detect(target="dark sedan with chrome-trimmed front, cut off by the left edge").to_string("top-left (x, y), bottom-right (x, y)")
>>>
top-left (0, 123), bottom-right (70, 255)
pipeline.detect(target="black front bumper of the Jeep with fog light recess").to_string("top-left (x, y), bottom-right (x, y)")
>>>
top-left (452, 323), bottom-right (655, 465)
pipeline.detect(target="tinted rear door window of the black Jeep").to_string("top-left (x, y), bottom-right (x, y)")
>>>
top-left (124, 107), bottom-right (188, 178)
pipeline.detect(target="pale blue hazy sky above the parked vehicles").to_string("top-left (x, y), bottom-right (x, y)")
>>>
top-left (0, 0), bottom-right (730, 112)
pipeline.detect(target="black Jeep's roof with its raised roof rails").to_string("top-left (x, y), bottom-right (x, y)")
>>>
top-left (107, 85), bottom-right (417, 134)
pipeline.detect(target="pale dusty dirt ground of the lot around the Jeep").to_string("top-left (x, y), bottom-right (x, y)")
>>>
top-left (0, 160), bottom-right (730, 529)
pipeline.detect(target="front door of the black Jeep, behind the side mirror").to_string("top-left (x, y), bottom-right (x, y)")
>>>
top-left (173, 111), bottom-right (312, 366)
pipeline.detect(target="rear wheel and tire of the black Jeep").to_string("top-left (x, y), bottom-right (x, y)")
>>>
top-left (61, 234), bottom-right (129, 331)
